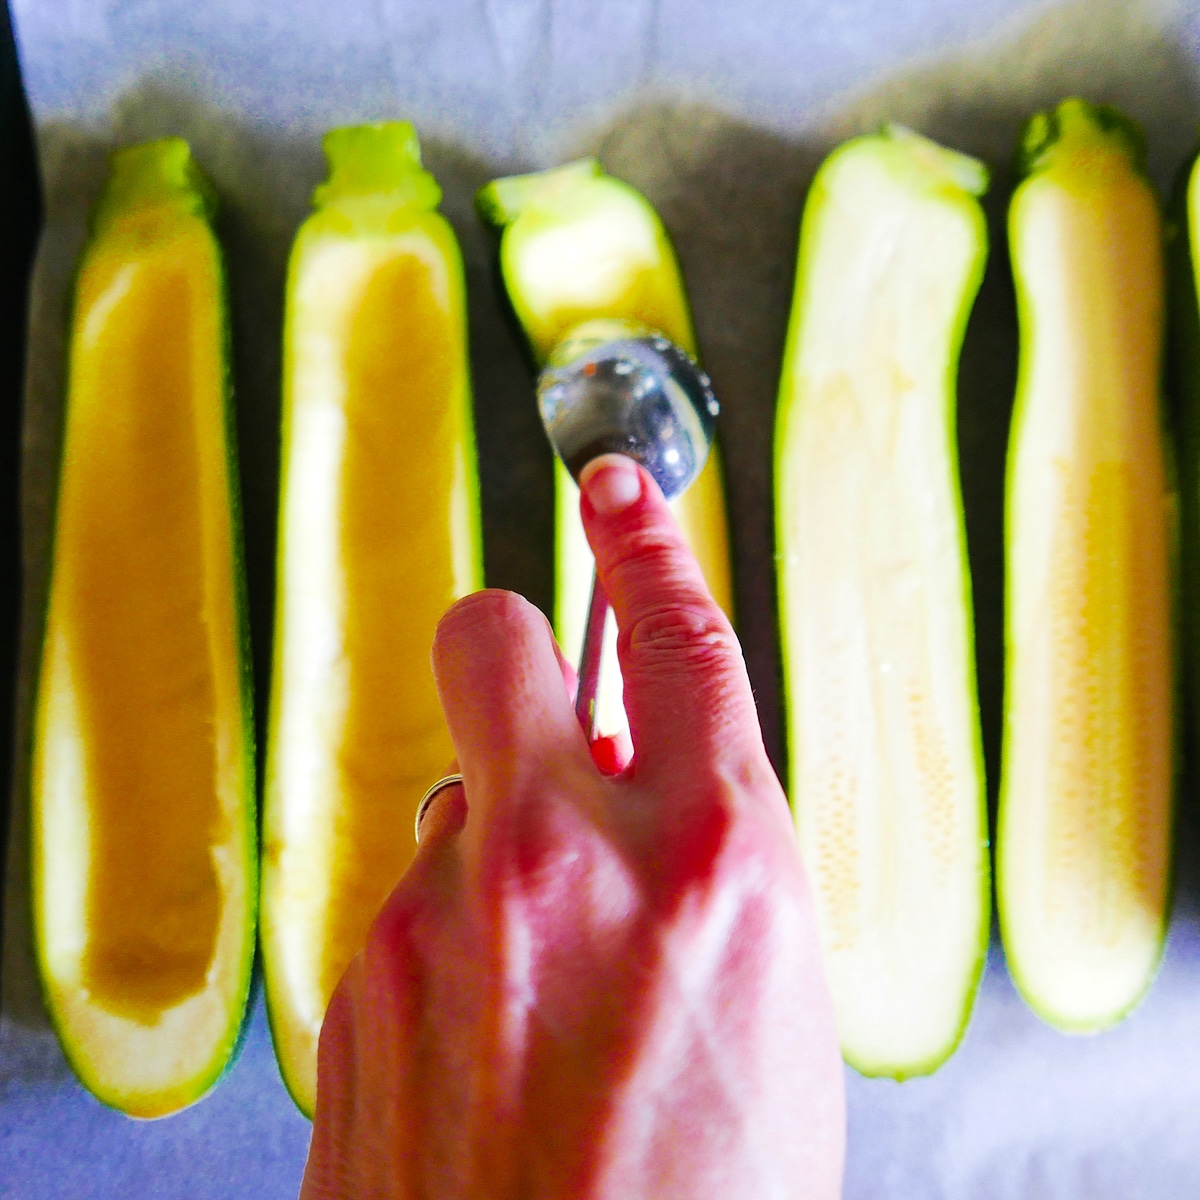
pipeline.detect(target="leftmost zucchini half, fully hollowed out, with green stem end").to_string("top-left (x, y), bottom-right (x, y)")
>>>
top-left (31, 138), bottom-right (256, 1117)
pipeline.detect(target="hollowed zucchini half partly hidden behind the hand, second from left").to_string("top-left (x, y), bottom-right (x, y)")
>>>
top-left (262, 124), bottom-right (482, 1114)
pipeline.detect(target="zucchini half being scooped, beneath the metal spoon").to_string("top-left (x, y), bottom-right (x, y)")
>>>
top-left (478, 158), bottom-right (733, 733)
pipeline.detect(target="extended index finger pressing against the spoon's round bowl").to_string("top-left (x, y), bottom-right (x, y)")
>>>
top-left (580, 455), bottom-right (762, 772)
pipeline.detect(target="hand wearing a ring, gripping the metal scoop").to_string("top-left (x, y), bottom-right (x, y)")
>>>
top-left (301, 456), bottom-right (845, 1200)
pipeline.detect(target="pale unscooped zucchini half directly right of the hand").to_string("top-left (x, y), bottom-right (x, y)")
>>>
top-left (775, 128), bottom-right (989, 1079)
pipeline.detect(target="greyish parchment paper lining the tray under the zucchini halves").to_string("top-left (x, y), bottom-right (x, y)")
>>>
top-left (0, 0), bottom-right (1200, 1200)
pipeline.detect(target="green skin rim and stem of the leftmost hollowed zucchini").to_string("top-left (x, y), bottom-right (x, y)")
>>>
top-left (29, 138), bottom-right (258, 1118)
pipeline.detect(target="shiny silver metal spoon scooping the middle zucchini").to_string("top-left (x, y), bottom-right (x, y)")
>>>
top-left (538, 319), bottom-right (720, 742)
